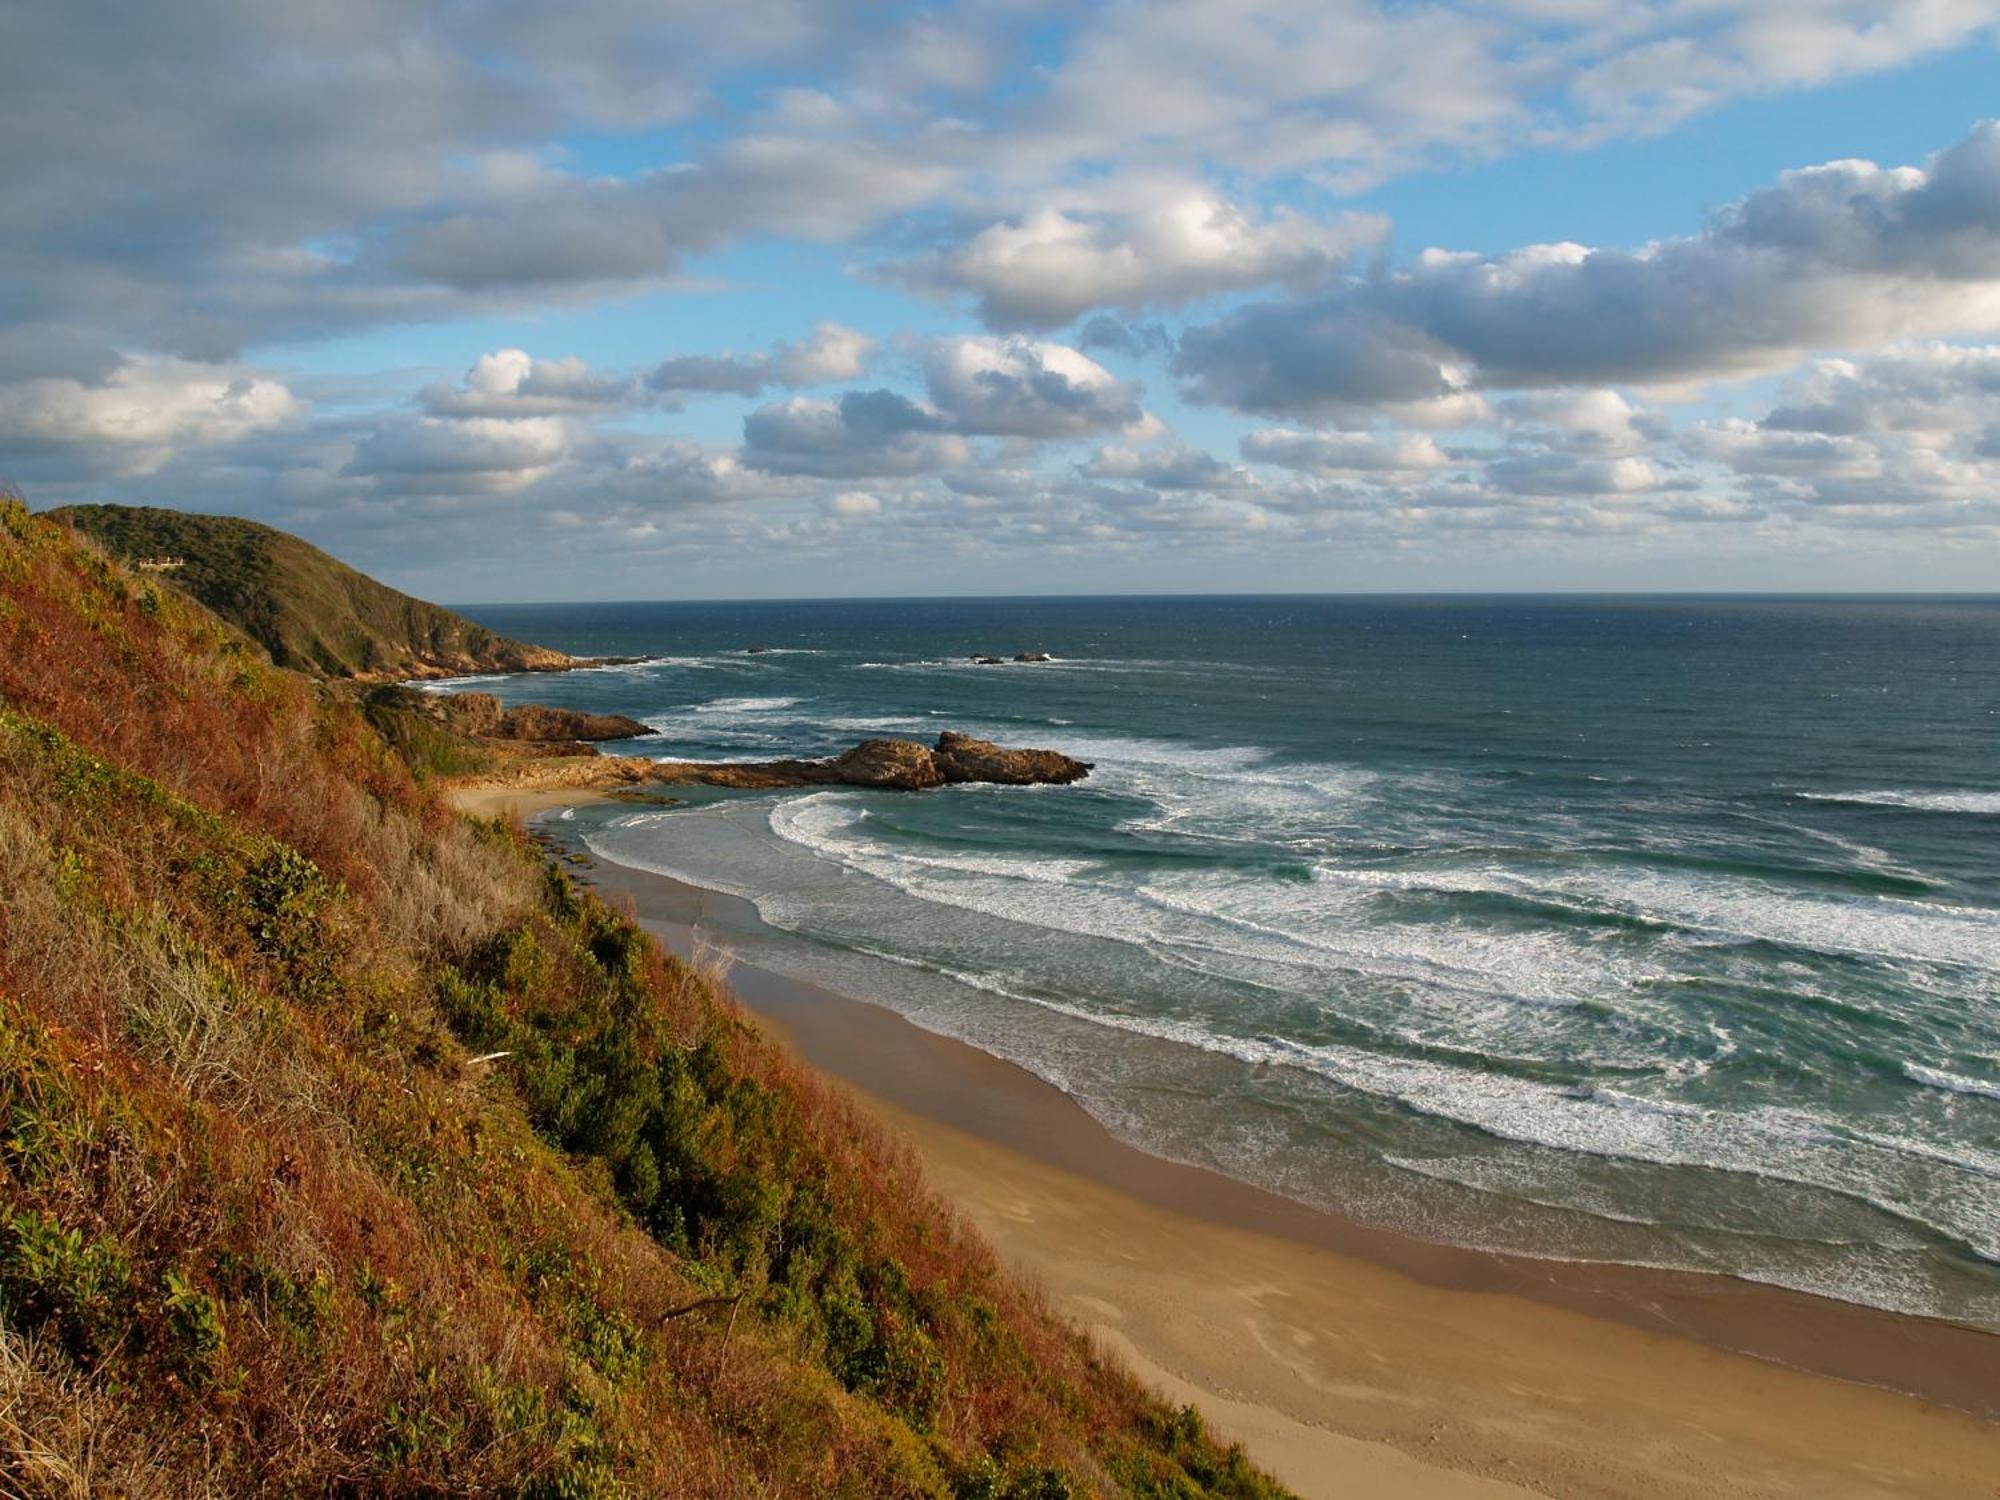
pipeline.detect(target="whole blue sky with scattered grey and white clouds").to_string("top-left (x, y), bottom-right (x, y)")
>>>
top-left (0, 0), bottom-right (2000, 602)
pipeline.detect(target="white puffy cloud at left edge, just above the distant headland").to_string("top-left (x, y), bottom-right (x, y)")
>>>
top-left (0, 358), bottom-right (306, 478)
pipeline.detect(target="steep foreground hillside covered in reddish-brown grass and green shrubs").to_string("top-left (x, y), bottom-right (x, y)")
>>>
top-left (0, 502), bottom-right (1276, 1500)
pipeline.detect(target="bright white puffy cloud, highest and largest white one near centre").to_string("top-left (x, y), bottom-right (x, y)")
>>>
top-left (892, 190), bottom-right (1388, 330)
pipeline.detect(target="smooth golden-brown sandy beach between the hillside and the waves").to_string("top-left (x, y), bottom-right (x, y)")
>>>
top-left (460, 792), bottom-right (2000, 1500)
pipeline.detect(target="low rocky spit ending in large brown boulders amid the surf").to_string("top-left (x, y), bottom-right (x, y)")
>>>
top-left (456, 730), bottom-right (1090, 792)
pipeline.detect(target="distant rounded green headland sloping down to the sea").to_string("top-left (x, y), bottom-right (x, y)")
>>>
top-left (48, 506), bottom-right (568, 680)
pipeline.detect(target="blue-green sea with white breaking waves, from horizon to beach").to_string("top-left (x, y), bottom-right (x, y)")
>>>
top-left (442, 598), bottom-right (2000, 1326)
